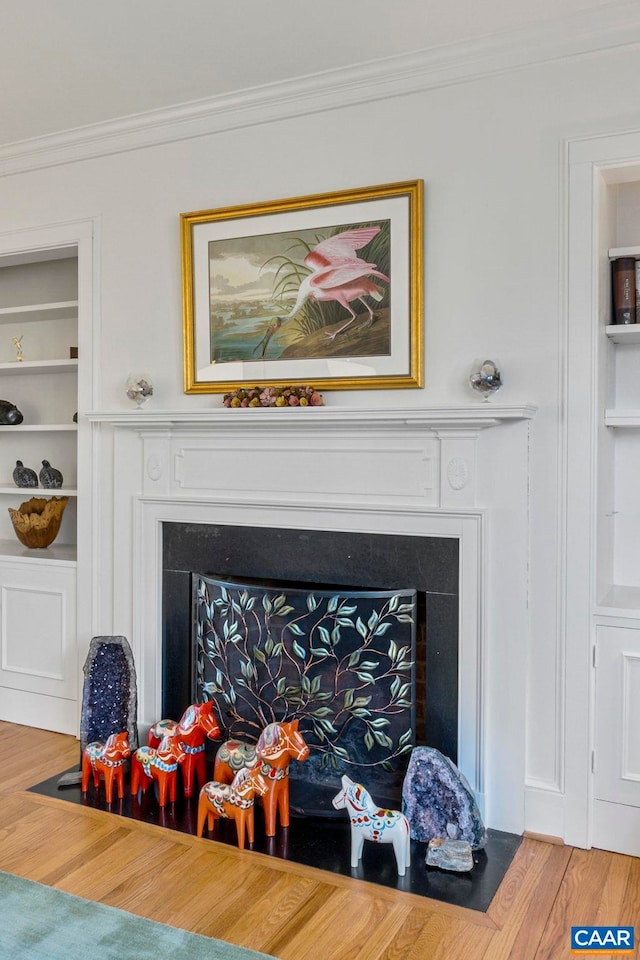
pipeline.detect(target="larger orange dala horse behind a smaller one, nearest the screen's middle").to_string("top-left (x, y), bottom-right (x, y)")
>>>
top-left (213, 720), bottom-right (309, 837)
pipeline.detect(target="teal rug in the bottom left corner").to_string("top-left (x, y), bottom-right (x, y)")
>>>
top-left (0, 872), bottom-right (274, 960)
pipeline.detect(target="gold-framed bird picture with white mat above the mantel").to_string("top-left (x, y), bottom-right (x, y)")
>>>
top-left (180, 180), bottom-right (423, 393)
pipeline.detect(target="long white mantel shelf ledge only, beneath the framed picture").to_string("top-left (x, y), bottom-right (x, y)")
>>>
top-left (86, 401), bottom-right (537, 430)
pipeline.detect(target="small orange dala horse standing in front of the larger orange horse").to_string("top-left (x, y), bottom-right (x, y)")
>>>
top-left (197, 765), bottom-right (269, 850)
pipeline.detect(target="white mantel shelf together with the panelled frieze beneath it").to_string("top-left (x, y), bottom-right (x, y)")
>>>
top-left (88, 401), bottom-right (536, 508)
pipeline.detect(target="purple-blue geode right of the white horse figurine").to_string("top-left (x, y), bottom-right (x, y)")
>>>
top-left (402, 747), bottom-right (487, 850)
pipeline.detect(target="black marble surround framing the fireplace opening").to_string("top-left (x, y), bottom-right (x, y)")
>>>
top-left (162, 523), bottom-right (459, 776)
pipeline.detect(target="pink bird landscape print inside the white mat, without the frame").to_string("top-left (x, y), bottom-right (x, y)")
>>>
top-left (202, 220), bottom-right (391, 364)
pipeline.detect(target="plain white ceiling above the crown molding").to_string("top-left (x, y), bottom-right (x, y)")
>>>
top-left (0, 0), bottom-right (632, 145)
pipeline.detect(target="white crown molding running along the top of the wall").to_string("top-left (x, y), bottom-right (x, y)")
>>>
top-left (0, 0), bottom-right (640, 176)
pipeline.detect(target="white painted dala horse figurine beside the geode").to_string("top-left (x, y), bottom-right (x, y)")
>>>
top-left (332, 776), bottom-right (411, 877)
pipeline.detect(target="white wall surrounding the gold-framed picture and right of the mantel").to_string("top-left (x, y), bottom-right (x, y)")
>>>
top-left (0, 51), bottom-right (640, 833)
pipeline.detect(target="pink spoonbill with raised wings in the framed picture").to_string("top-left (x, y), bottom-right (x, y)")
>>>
top-left (255, 226), bottom-right (390, 357)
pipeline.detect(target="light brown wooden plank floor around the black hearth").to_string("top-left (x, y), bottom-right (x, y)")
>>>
top-left (0, 722), bottom-right (640, 960)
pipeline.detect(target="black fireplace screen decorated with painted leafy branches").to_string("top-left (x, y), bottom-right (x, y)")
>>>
top-left (193, 574), bottom-right (416, 797)
